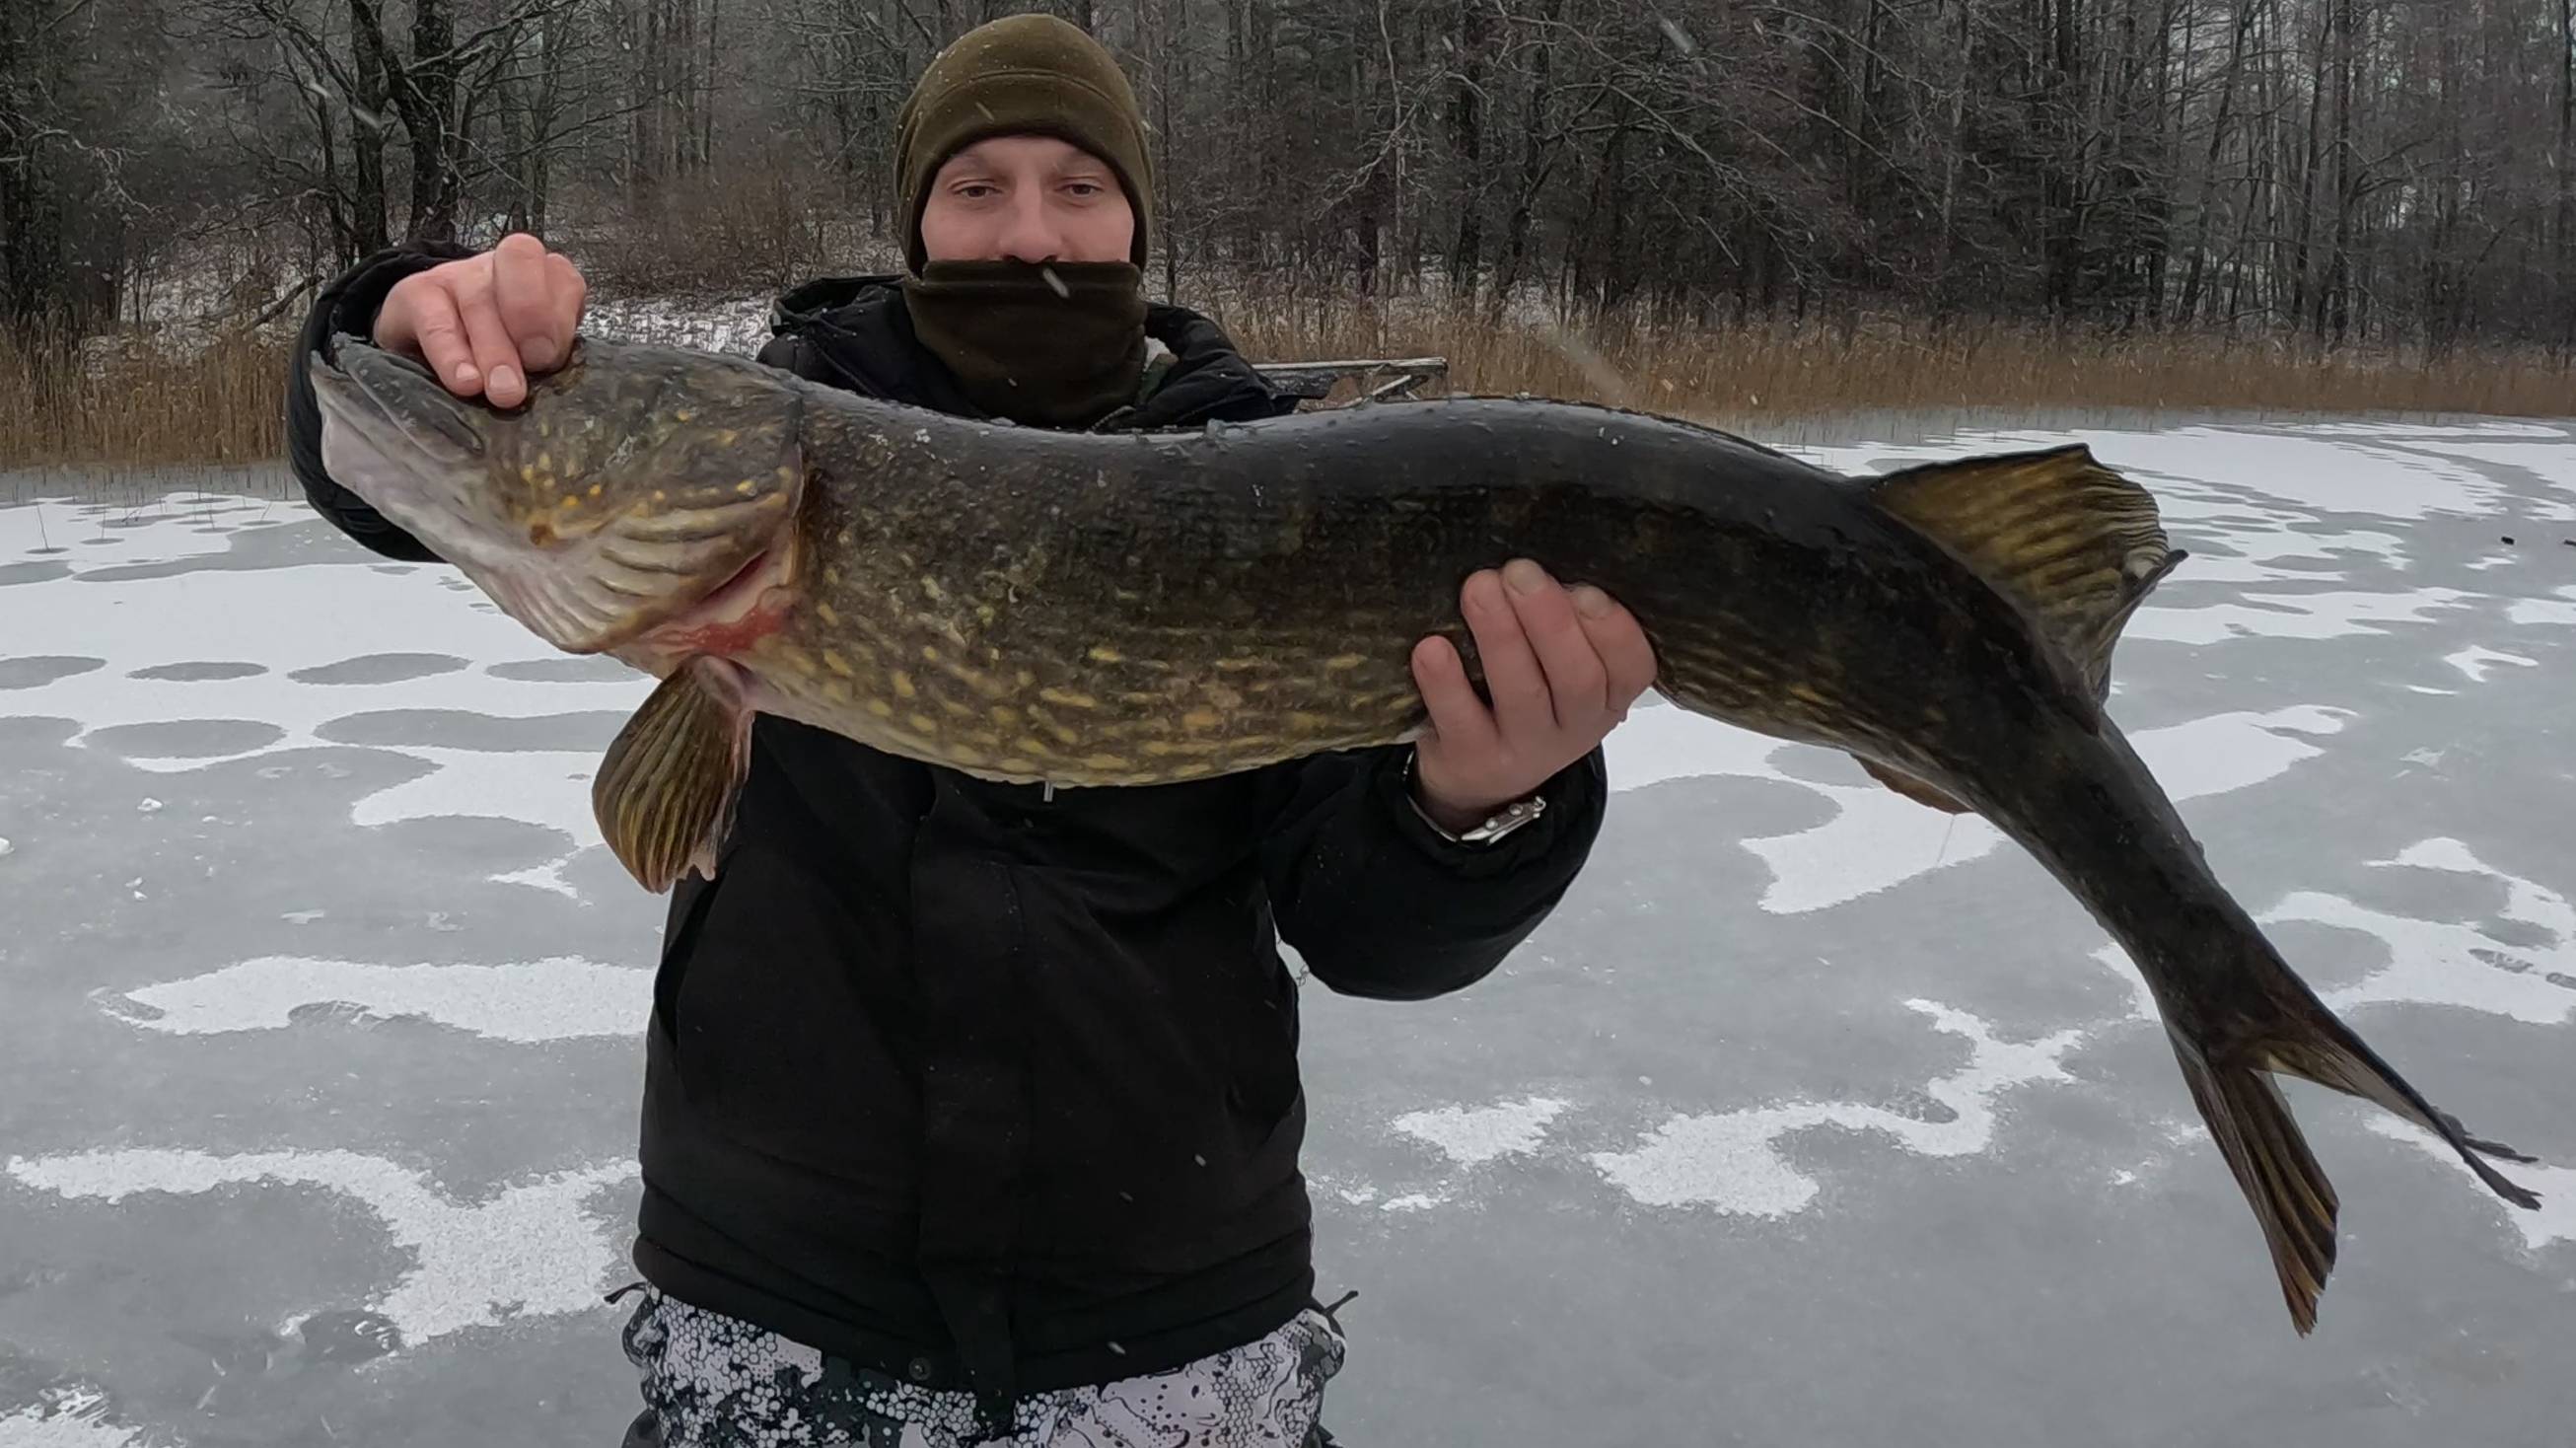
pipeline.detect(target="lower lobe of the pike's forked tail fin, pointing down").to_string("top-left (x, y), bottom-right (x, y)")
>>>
top-left (2175, 1039), bottom-right (2339, 1338)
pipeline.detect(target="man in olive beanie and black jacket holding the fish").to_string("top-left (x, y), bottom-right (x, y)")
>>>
top-left (289, 16), bottom-right (1654, 1448)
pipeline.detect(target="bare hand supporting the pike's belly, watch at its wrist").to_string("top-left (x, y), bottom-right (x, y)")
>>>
top-left (1414, 559), bottom-right (1654, 833)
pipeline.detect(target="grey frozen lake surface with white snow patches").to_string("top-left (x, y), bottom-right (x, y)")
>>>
top-left (0, 420), bottom-right (2576, 1448)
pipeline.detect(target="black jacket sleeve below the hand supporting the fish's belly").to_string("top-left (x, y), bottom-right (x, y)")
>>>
top-left (1262, 745), bottom-right (1610, 999)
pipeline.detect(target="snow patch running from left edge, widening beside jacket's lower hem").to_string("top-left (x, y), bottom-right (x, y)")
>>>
top-left (8, 1149), bottom-right (634, 1349)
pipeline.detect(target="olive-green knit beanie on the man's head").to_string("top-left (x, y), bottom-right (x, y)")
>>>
top-left (894, 16), bottom-right (1154, 273)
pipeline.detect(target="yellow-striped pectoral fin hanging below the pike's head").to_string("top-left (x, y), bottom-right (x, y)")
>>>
top-left (590, 657), bottom-right (752, 894)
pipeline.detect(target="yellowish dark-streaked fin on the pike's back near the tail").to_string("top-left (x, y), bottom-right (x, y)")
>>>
top-left (1873, 443), bottom-right (2187, 706)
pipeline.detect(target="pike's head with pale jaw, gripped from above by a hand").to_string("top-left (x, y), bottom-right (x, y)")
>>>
top-left (307, 337), bottom-right (807, 654)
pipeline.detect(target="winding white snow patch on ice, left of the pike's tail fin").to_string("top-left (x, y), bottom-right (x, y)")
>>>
top-left (1592, 999), bottom-right (2084, 1219)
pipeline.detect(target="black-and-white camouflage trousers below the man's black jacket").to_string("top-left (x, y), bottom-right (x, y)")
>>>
top-left (623, 1285), bottom-right (1342, 1448)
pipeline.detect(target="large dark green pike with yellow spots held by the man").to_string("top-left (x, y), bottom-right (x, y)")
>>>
top-left (309, 340), bottom-right (2538, 1332)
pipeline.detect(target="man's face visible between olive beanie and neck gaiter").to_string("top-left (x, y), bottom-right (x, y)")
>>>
top-left (922, 136), bottom-right (1136, 260)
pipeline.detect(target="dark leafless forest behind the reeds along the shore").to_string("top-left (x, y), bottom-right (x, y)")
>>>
top-left (0, 0), bottom-right (2576, 464)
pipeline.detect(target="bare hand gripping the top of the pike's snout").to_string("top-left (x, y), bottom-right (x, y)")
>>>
top-left (376, 232), bottom-right (590, 407)
